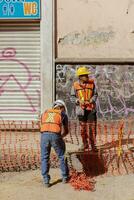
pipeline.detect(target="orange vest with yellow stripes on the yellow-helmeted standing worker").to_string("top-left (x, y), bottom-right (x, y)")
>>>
top-left (74, 80), bottom-right (95, 110)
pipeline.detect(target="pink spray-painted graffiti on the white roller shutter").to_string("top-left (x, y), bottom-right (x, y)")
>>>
top-left (0, 48), bottom-right (40, 118)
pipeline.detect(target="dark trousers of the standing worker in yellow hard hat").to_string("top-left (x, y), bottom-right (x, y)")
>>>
top-left (78, 110), bottom-right (97, 149)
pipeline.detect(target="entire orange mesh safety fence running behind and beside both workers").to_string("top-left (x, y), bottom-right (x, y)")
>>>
top-left (0, 118), bottom-right (134, 177)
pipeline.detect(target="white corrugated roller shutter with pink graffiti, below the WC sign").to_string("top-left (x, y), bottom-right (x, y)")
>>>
top-left (0, 22), bottom-right (40, 120)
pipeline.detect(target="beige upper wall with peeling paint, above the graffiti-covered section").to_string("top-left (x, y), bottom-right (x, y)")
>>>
top-left (57, 0), bottom-right (134, 60)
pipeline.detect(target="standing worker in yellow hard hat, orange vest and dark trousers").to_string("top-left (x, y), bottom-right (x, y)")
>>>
top-left (71, 66), bottom-right (98, 151)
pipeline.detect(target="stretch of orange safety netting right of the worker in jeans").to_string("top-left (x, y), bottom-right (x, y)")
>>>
top-left (69, 119), bottom-right (134, 176)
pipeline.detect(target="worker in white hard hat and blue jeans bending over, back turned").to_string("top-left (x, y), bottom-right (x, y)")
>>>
top-left (40, 100), bottom-right (68, 187)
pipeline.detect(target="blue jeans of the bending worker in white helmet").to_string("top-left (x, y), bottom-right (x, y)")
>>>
top-left (41, 132), bottom-right (68, 183)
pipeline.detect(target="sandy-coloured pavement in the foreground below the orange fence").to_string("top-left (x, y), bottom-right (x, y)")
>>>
top-left (0, 169), bottom-right (134, 200)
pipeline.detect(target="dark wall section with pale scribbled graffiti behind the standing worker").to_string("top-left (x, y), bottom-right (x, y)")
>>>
top-left (56, 64), bottom-right (134, 119)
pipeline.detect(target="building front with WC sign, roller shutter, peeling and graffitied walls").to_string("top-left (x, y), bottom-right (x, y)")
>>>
top-left (0, 0), bottom-right (134, 121)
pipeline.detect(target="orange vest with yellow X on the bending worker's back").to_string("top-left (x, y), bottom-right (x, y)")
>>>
top-left (40, 109), bottom-right (62, 133)
